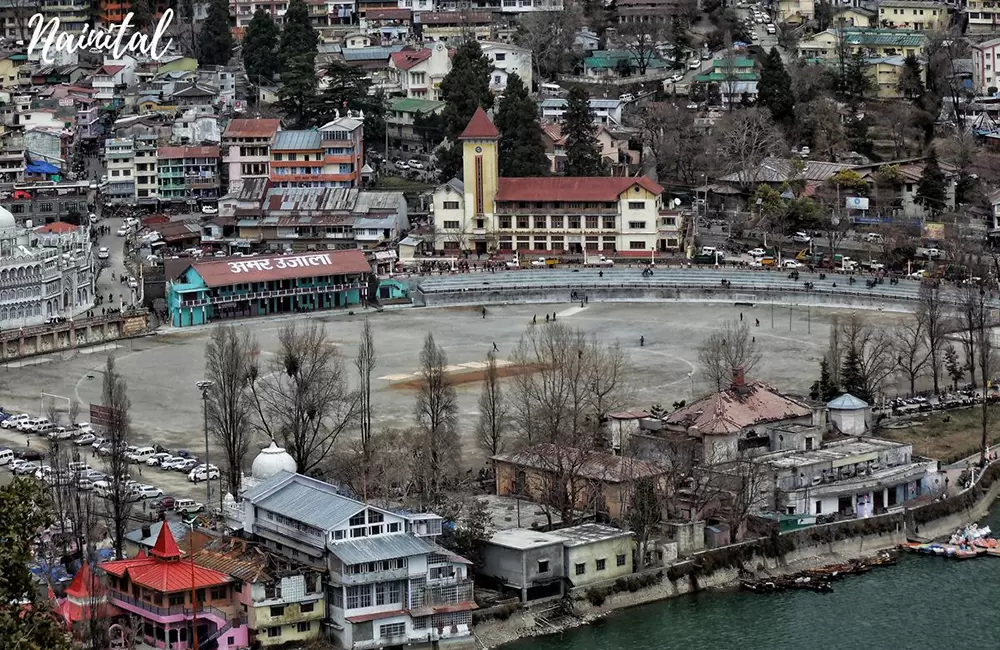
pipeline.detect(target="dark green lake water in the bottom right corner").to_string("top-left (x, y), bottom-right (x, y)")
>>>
top-left (504, 508), bottom-right (1000, 650)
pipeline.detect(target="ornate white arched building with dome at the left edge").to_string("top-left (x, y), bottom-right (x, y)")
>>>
top-left (0, 208), bottom-right (94, 330)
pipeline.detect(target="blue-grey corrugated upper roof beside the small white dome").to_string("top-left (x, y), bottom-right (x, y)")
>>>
top-left (250, 472), bottom-right (365, 531)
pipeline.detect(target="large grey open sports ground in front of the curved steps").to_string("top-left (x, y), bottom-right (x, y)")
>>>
top-left (0, 303), bottom-right (920, 468)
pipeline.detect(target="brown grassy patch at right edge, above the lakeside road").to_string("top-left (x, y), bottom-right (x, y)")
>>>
top-left (878, 406), bottom-right (1000, 462)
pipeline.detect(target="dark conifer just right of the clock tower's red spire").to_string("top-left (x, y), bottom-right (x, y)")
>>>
top-left (495, 73), bottom-right (548, 176)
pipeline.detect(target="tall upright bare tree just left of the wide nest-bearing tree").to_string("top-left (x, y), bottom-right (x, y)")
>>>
top-left (205, 325), bottom-right (260, 496)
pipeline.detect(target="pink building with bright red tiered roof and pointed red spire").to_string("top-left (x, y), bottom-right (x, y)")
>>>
top-left (100, 526), bottom-right (248, 650)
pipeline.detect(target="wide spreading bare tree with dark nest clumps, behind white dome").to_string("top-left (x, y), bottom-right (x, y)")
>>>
top-left (250, 322), bottom-right (360, 474)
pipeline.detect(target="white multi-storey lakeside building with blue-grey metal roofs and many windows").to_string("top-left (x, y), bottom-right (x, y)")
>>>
top-left (227, 471), bottom-right (476, 650)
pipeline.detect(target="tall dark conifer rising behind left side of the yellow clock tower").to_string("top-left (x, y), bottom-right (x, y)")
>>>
top-left (438, 39), bottom-right (493, 180)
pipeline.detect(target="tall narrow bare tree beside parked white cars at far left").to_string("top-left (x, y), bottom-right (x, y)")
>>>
top-left (101, 355), bottom-right (135, 560)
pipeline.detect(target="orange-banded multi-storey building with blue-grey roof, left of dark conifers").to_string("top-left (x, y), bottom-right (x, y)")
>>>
top-left (270, 117), bottom-right (365, 187)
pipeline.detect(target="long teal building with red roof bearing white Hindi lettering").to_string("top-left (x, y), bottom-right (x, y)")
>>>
top-left (167, 250), bottom-right (371, 327)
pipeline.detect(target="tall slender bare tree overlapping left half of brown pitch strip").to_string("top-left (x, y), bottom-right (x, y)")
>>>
top-left (414, 332), bottom-right (459, 502)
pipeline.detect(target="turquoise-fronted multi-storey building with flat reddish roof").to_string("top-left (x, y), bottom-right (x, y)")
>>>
top-left (156, 147), bottom-right (221, 204)
